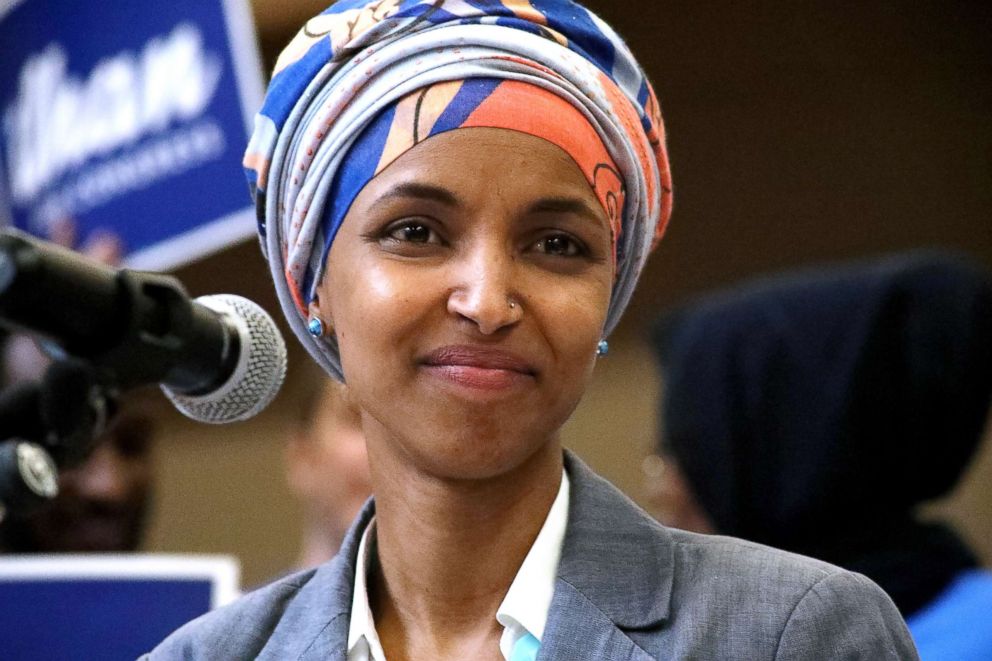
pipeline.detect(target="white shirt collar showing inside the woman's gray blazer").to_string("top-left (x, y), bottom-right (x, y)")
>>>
top-left (348, 470), bottom-right (569, 661)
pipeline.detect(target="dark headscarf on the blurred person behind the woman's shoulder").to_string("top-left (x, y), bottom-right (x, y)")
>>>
top-left (655, 253), bottom-right (992, 616)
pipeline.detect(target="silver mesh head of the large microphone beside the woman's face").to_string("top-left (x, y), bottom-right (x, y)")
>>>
top-left (162, 294), bottom-right (286, 424)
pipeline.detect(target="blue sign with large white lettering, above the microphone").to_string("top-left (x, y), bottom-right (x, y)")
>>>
top-left (0, 0), bottom-right (262, 269)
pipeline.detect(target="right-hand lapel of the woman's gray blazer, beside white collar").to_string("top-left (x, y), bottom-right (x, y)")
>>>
top-left (538, 451), bottom-right (674, 661)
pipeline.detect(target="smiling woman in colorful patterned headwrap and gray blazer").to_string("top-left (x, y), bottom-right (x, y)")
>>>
top-left (143, 0), bottom-right (915, 661)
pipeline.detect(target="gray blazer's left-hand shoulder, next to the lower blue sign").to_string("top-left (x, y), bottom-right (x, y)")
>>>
top-left (142, 569), bottom-right (315, 661)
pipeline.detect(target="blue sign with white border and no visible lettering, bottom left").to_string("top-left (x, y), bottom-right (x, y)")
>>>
top-left (0, 555), bottom-right (238, 661)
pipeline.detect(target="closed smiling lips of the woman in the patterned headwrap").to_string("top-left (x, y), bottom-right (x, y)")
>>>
top-left (424, 345), bottom-right (535, 390)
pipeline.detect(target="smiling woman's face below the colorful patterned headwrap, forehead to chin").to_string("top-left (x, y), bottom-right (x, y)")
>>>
top-left (314, 128), bottom-right (613, 479)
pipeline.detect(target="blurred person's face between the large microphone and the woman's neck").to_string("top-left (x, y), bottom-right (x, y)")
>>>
top-left (286, 365), bottom-right (372, 569)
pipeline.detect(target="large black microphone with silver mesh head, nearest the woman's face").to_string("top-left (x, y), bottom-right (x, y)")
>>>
top-left (0, 229), bottom-right (286, 422)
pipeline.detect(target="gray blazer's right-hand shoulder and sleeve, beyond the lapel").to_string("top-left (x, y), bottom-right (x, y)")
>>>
top-left (652, 529), bottom-right (918, 660)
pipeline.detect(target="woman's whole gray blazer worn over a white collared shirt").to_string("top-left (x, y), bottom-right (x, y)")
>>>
top-left (143, 452), bottom-right (918, 661)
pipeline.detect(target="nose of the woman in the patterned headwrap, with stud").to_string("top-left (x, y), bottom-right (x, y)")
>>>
top-left (448, 240), bottom-right (524, 335)
